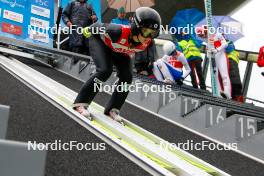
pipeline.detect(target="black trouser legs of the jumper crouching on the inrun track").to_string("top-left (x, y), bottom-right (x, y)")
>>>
top-left (74, 36), bottom-right (132, 115)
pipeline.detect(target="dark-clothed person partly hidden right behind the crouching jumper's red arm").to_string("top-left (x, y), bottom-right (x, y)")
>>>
top-left (135, 41), bottom-right (156, 76)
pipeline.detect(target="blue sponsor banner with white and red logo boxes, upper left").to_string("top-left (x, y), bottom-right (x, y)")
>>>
top-left (0, 0), bottom-right (54, 46)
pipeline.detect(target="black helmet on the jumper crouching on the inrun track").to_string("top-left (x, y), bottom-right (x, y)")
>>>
top-left (131, 7), bottom-right (161, 38)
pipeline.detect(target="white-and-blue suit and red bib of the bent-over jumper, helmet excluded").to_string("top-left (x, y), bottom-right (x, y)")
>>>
top-left (153, 52), bottom-right (191, 82)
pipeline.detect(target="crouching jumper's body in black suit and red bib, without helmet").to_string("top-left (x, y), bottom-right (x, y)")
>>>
top-left (74, 23), bottom-right (151, 115)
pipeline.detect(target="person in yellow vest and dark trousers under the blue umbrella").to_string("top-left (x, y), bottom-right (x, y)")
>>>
top-left (178, 32), bottom-right (206, 90)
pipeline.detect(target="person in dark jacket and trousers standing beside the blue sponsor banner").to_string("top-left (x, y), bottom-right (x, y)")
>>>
top-left (62, 0), bottom-right (97, 63)
